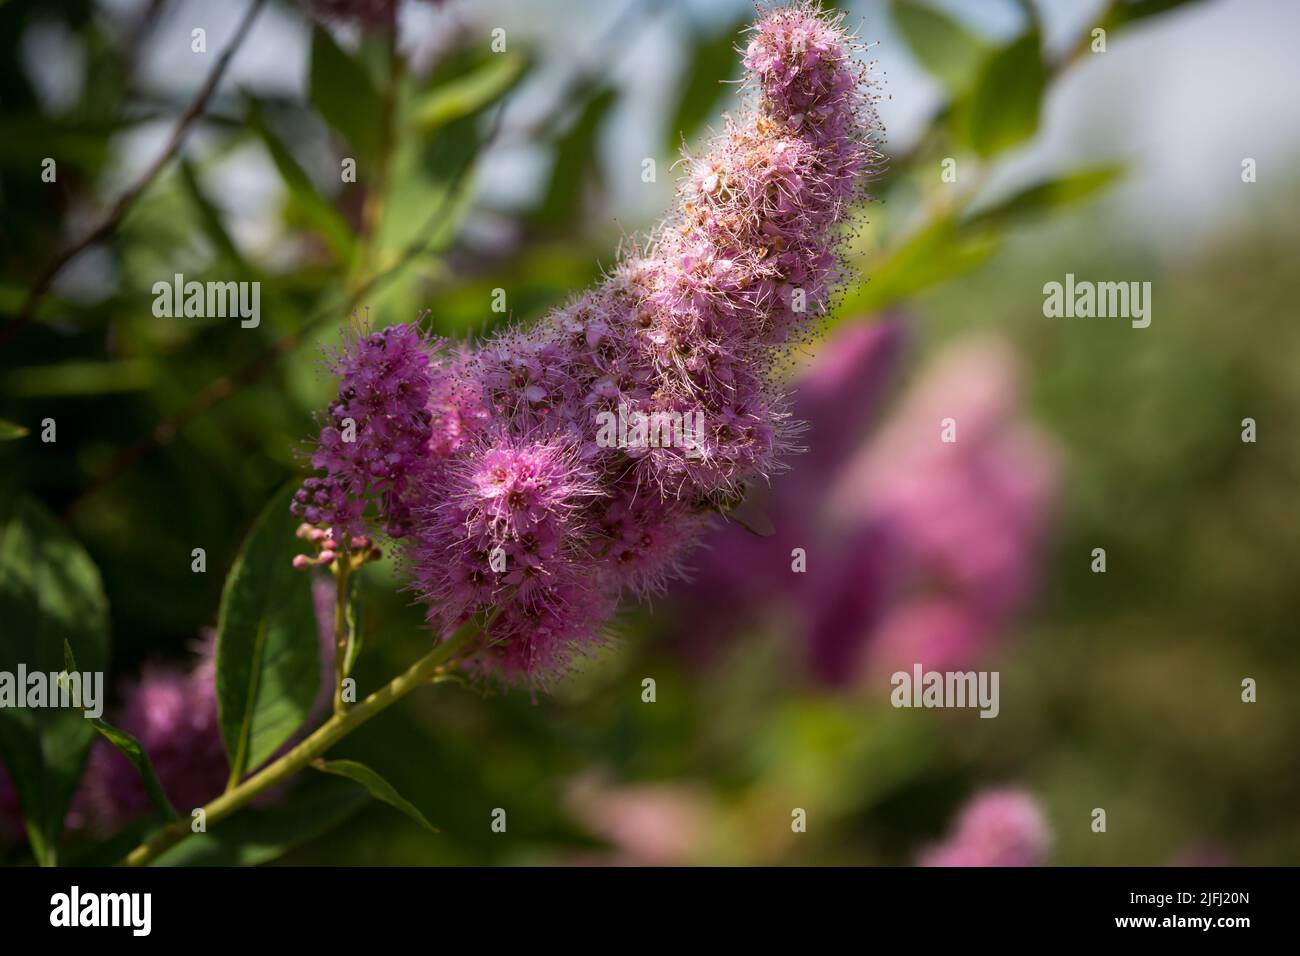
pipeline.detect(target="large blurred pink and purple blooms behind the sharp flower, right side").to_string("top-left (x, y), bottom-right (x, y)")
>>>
top-left (685, 325), bottom-right (1057, 684)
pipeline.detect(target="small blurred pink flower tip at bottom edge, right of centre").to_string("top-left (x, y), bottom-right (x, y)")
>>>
top-left (918, 790), bottom-right (1052, 866)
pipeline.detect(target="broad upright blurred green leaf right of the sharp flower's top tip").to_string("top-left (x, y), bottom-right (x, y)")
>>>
top-left (954, 30), bottom-right (1048, 157)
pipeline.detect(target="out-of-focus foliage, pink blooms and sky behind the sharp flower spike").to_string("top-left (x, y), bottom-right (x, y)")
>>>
top-left (0, 0), bottom-right (1300, 865)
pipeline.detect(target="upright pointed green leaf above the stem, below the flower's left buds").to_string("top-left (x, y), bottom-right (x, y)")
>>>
top-left (217, 488), bottom-right (321, 782)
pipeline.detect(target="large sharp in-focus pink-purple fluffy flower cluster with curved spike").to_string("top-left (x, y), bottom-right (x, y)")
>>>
top-left (294, 4), bottom-right (876, 680)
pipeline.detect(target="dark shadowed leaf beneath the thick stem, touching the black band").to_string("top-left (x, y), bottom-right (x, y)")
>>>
top-left (152, 780), bottom-right (367, 866)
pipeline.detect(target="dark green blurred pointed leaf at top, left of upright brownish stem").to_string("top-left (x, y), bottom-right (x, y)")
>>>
top-left (309, 25), bottom-right (384, 170)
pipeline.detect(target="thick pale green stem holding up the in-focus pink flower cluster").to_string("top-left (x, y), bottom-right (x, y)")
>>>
top-left (124, 624), bottom-right (477, 866)
